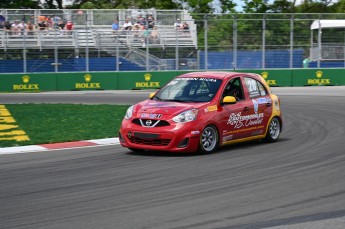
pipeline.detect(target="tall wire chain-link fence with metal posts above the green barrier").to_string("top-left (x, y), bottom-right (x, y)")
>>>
top-left (0, 9), bottom-right (345, 73)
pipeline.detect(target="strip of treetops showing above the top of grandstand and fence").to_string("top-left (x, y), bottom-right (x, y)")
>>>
top-left (0, 0), bottom-right (345, 14)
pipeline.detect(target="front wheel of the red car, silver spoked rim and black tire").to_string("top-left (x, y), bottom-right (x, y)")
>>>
top-left (199, 125), bottom-right (219, 153)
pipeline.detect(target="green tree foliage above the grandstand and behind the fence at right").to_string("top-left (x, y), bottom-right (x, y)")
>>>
top-left (0, 0), bottom-right (345, 50)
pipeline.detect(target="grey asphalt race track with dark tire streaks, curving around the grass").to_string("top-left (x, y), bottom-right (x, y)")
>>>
top-left (0, 87), bottom-right (345, 229)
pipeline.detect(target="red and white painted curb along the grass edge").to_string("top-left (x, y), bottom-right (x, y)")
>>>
top-left (0, 138), bottom-right (120, 155)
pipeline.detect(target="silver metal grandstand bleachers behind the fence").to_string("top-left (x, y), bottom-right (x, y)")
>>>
top-left (0, 9), bottom-right (197, 71)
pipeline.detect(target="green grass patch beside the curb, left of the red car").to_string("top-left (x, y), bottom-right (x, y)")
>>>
top-left (0, 104), bottom-right (129, 147)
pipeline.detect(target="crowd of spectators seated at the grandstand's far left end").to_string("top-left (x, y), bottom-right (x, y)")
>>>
top-left (0, 15), bottom-right (74, 36)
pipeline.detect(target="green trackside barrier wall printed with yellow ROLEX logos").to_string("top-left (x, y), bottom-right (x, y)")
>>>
top-left (0, 69), bottom-right (345, 92)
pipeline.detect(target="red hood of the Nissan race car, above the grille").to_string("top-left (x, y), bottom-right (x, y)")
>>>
top-left (135, 99), bottom-right (205, 118)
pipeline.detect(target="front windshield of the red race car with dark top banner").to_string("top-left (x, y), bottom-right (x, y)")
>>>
top-left (153, 77), bottom-right (222, 102)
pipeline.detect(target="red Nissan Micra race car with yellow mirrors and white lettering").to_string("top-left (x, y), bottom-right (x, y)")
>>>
top-left (119, 72), bottom-right (282, 152)
